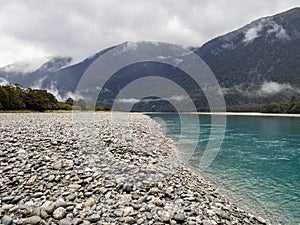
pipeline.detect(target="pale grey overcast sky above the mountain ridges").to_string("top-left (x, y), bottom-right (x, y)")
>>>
top-left (0, 0), bottom-right (300, 67)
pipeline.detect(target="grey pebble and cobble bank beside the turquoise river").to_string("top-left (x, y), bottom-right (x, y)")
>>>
top-left (0, 113), bottom-right (266, 225)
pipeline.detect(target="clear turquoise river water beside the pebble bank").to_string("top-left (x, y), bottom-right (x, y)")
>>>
top-left (150, 114), bottom-right (300, 224)
